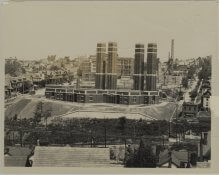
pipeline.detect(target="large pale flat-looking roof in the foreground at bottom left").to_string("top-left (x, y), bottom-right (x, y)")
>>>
top-left (33, 146), bottom-right (110, 167)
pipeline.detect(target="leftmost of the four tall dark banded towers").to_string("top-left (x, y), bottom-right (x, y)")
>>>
top-left (95, 43), bottom-right (106, 89)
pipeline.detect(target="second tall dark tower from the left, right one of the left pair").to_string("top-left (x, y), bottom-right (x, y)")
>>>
top-left (106, 42), bottom-right (118, 89)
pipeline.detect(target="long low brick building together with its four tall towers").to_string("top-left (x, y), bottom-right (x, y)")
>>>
top-left (45, 42), bottom-right (159, 105)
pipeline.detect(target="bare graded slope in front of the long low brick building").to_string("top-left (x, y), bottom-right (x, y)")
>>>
top-left (5, 97), bottom-right (175, 120)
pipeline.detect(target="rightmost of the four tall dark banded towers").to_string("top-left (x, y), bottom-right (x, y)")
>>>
top-left (146, 43), bottom-right (157, 91)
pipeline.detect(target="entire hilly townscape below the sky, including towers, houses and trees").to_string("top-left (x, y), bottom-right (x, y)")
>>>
top-left (4, 39), bottom-right (212, 168)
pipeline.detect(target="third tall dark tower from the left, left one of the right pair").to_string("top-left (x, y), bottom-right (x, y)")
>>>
top-left (133, 44), bottom-right (144, 90)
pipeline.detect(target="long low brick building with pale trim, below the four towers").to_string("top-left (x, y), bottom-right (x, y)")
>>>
top-left (45, 85), bottom-right (159, 105)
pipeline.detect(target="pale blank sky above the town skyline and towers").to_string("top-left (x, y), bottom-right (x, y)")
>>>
top-left (0, 1), bottom-right (217, 60)
